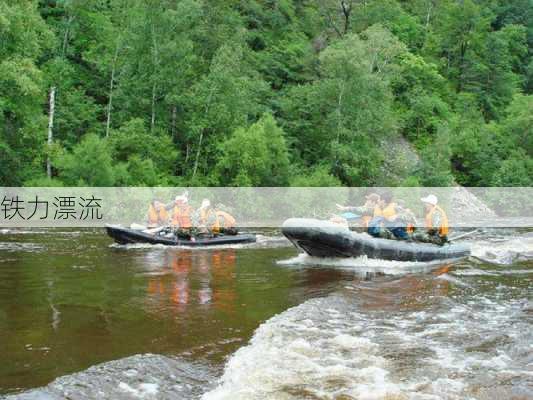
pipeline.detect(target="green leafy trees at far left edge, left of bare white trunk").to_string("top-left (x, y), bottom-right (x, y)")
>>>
top-left (0, 0), bottom-right (54, 185)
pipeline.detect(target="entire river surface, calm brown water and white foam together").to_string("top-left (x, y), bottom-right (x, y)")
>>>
top-left (0, 230), bottom-right (533, 400)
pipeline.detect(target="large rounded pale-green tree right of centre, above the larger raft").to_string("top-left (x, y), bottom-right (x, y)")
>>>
top-left (283, 26), bottom-right (405, 185)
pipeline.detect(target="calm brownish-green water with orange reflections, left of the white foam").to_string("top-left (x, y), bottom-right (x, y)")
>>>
top-left (0, 230), bottom-right (336, 393)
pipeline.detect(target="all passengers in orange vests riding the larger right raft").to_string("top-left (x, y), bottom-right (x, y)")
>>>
top-left (331, 192), bottom-right (449, 245)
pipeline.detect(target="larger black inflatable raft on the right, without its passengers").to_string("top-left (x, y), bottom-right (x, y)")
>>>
top-left (282, 218), bottom-right (470, 262)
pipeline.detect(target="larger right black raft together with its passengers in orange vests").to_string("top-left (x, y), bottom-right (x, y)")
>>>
top-left (281, 192), bottom-right (473, 262)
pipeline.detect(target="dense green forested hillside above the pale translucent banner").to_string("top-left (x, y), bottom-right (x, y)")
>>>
top-left (0, 0), bottom-right (533, 186)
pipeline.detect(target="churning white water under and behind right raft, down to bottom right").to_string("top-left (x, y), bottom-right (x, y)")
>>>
top-left (202, 233), bottom-right (533, 400)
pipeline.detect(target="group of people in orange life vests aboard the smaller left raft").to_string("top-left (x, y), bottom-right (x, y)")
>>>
top-left (144, 192), bottom-right (237, 241)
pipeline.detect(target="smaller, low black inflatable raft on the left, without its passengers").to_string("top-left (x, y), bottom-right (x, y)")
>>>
top-left (106, 225), bottom-right (256, 246)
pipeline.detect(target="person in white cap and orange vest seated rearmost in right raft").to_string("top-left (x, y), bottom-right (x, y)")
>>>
top-left (412, 194), bottom-right (449, 246)
